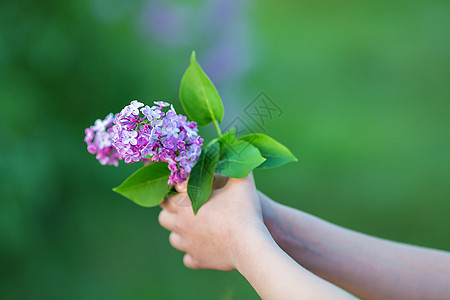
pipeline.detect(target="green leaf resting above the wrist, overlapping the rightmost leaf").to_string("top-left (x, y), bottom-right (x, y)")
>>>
top-left (216, 141), bottom-right (265, 178)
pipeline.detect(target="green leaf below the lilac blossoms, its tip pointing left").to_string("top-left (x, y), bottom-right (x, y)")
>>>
top-left (113, 162), bottom-right (170, 207)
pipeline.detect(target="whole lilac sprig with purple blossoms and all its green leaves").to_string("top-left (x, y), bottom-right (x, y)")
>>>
top-left (84, 52), bottom-right (297, 213)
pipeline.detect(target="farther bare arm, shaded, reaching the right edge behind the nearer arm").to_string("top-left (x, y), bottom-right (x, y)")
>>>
top-left (259, 193), bottom-right (450, 299)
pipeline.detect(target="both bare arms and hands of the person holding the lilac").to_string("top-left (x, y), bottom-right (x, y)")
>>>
top-left (159, 175), bottom-right (450, 299)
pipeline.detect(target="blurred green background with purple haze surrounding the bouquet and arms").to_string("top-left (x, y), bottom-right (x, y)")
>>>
top-left (0, 0), bottom-right (450, 299)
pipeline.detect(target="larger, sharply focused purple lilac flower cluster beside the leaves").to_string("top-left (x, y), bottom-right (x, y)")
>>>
top-left (112, 100), bottom-right (203, 185)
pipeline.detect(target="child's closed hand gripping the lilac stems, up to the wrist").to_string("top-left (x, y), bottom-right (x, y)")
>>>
top-left (159, 174), bottom-right (265, 271)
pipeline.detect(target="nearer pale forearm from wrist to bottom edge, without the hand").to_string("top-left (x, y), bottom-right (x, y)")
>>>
top-left (235, 226), bottom-right (353, 300)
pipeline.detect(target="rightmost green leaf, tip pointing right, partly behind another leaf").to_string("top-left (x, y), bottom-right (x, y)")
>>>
top-left (239, 133), bottom-right (298, 168)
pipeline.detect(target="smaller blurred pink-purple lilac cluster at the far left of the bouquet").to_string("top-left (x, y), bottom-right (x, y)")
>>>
top-left (84, 113), bottom-right (122, 167)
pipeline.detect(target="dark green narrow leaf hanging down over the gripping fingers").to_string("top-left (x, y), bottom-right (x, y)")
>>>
top-left (187, 143), bottom-right (220, 214)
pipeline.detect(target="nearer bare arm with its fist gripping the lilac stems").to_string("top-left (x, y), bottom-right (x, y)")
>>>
top-left (159, 176), bottom-right (353, 300)
